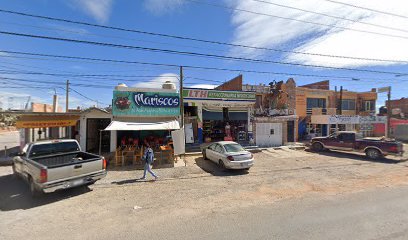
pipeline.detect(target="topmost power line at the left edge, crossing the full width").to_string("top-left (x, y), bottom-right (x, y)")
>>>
top-left (0, 9), bottom-right (408, 63)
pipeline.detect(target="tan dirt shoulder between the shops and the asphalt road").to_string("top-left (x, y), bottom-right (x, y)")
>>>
top-left (0, 148), bottom-right (408, 239)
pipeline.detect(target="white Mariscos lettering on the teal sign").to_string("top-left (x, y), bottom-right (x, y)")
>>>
top-left (134, 93), bottom-right (180, 107)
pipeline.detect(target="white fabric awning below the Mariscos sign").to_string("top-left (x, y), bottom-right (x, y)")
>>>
top-left (105, 120), bottom-right (180, 131)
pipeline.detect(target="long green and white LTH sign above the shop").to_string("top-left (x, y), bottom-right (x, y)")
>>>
top-left (183, 89), bottom-right (255, 101)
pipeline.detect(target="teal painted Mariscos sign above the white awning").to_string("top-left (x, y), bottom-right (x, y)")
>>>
top-left (112, 91), bottom-right (180, 116)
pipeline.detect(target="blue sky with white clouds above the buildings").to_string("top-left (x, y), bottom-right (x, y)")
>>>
top-left (0, 0), bottom-right (408, 108)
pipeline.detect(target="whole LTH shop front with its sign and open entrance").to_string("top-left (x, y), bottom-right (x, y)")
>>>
top-left (183, 88), bottom-right (255, 144)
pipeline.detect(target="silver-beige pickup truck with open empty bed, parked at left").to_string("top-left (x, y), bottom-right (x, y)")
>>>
top-left (12, 140), bottom-right (106, 197)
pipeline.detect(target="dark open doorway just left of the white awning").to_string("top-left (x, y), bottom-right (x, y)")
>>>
top-left (86, 118), bottom-right (111, 153)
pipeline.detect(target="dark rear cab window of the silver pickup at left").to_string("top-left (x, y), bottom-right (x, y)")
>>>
top-left (29, 142), bottom-right (79, 157)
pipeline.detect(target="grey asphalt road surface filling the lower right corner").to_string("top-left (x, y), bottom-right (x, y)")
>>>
top-left (131, 186), bottom-right (408, 240)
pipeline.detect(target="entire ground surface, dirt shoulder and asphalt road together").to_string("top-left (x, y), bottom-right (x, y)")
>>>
top-left (0, 149), bottom-right (408, 240)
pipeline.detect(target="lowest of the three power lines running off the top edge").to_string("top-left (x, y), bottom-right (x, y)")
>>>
top-left (186, 0), bottom-right (408, 39)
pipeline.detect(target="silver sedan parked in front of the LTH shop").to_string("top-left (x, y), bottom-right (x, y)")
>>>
top-left (202, 141), bottom-right (254, 170)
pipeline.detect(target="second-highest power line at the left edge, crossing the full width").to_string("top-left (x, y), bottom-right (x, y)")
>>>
top-left (0, 31), bottom-right (406, 75)
